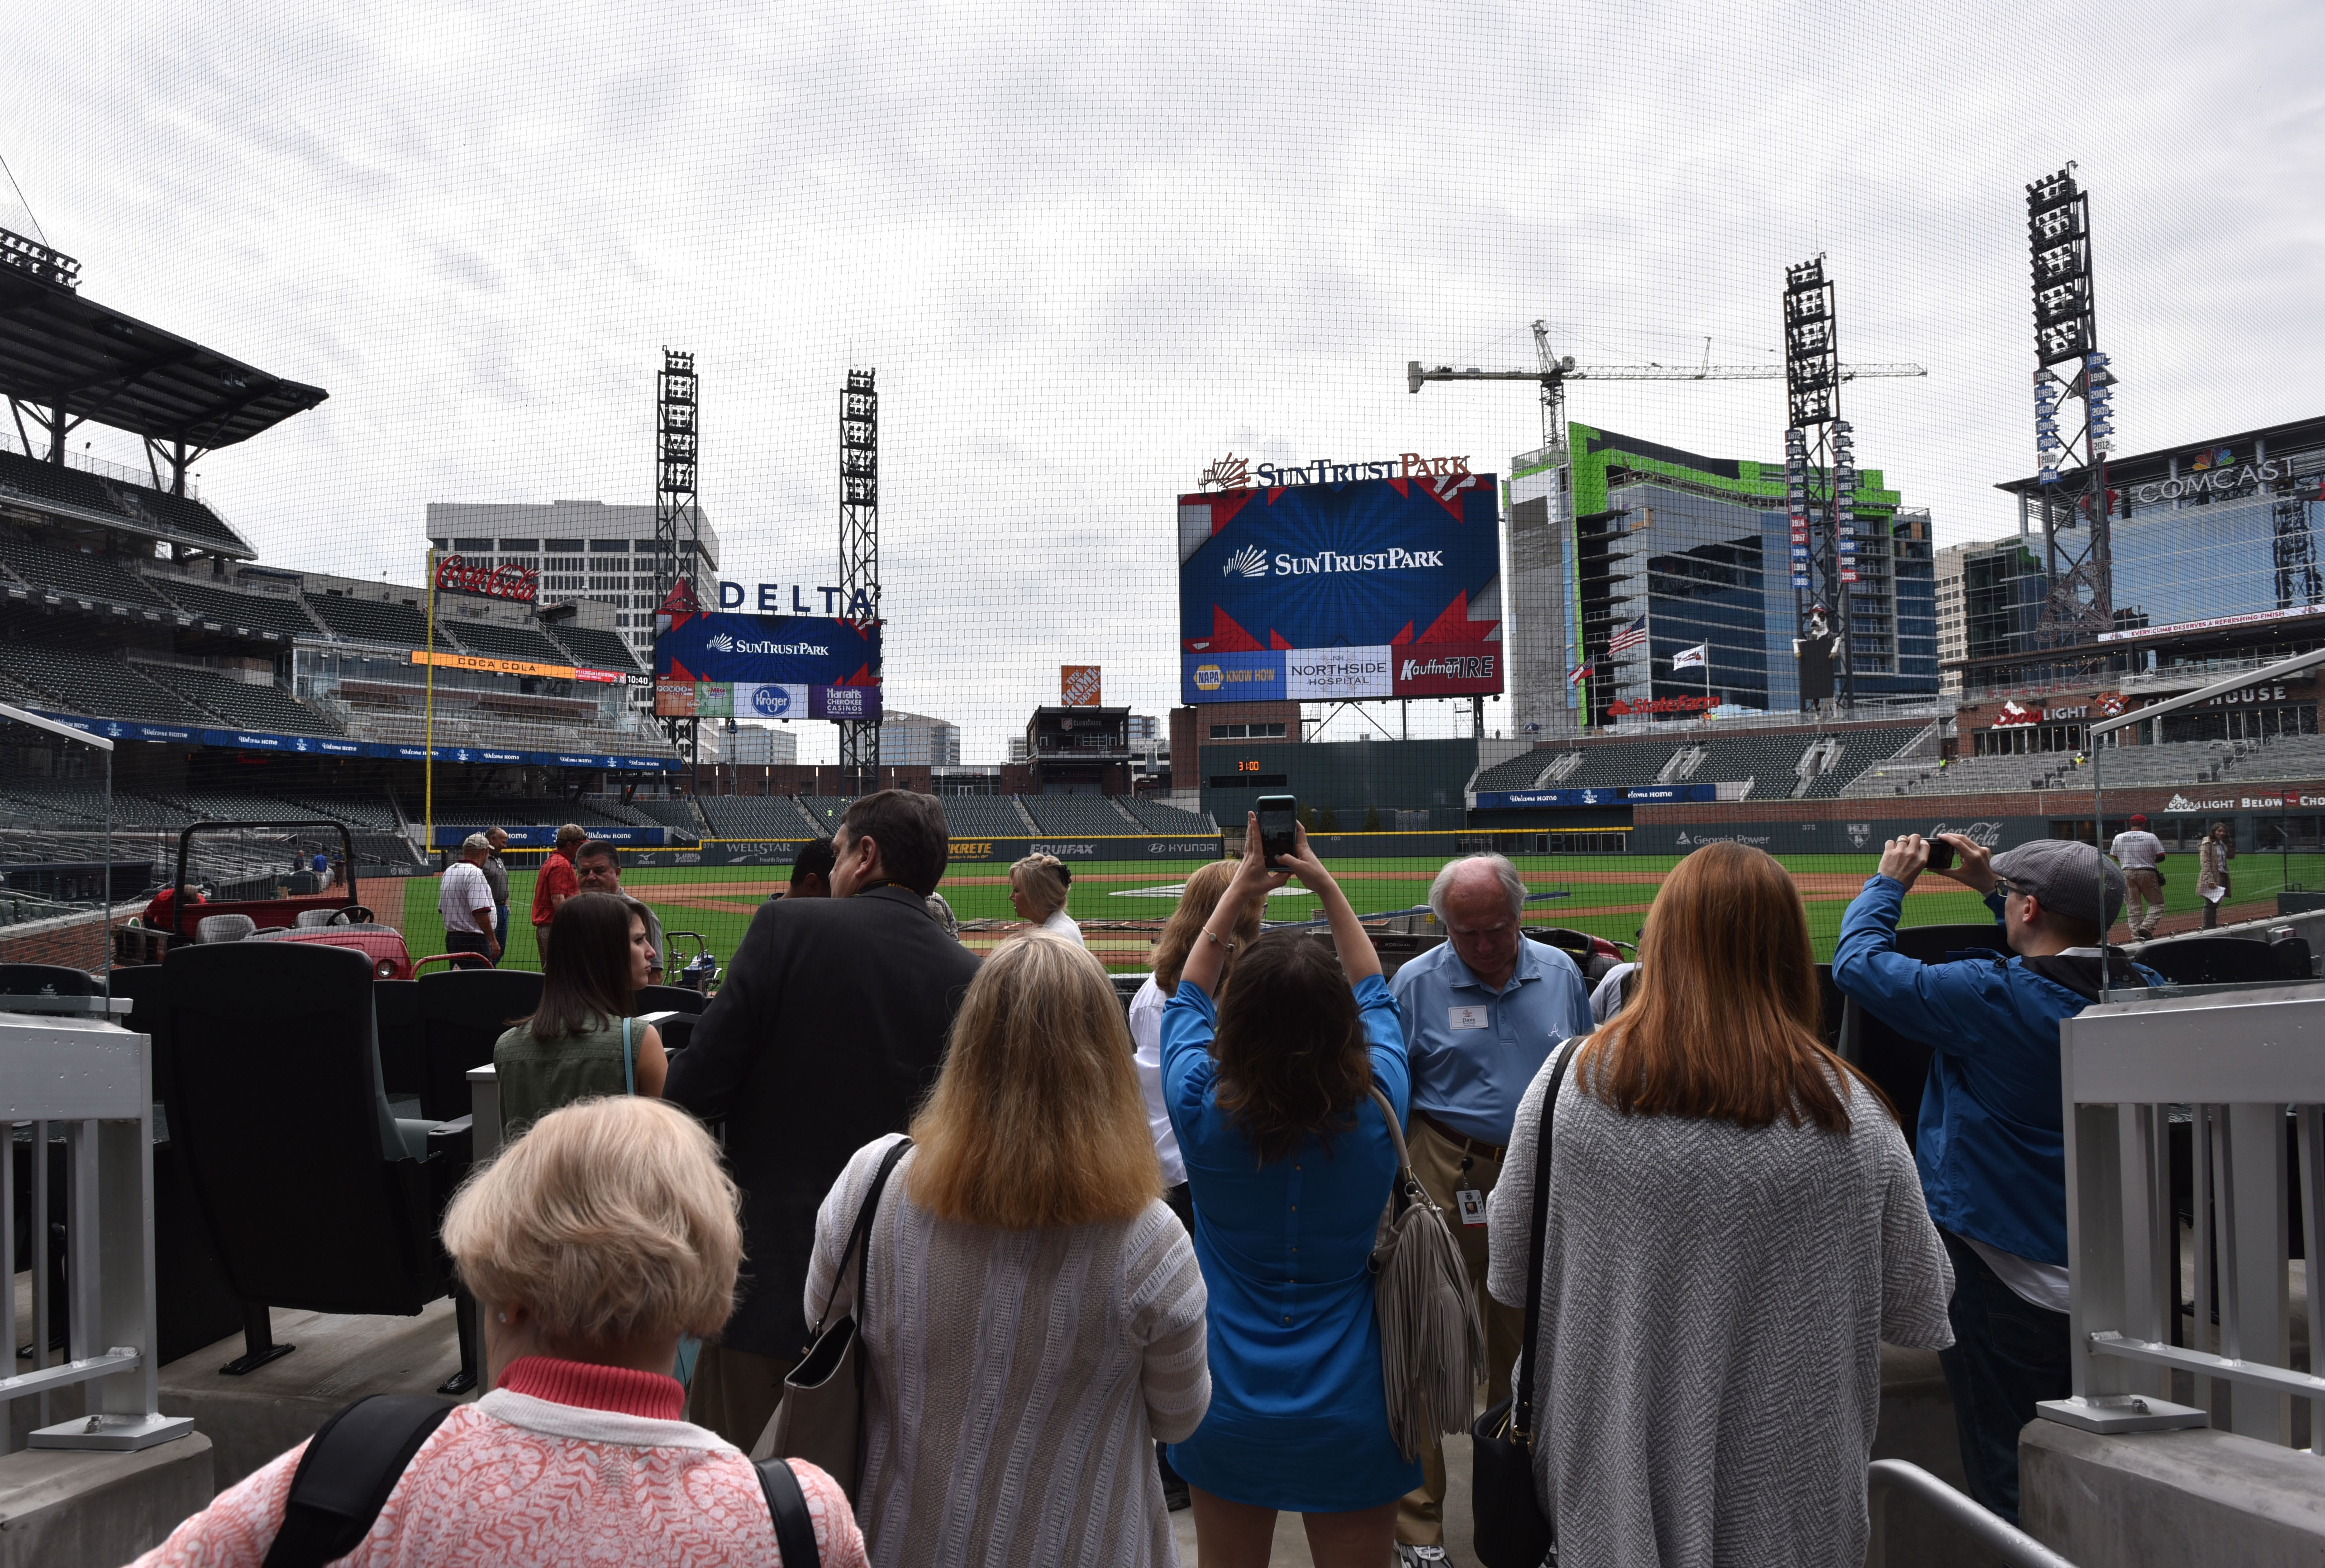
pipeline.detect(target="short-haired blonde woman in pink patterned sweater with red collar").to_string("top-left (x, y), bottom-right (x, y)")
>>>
top-left (137, 1098), bottom-right (865, 1568)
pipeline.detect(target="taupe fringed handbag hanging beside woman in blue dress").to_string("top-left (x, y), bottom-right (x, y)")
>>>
top-left (1372, 1089), bottom-right (1486, 1458)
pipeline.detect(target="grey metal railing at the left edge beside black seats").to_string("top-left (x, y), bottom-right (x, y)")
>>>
top-left (0, 996), bottom-right (193, 1452)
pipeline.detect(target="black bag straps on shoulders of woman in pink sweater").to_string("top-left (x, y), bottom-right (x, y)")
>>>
top-left (263, 1393), bottom-right (823, 1568)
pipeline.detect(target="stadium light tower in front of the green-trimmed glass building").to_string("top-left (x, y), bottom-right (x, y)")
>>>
top-left (1783, 256), bottom-right (1858, 712)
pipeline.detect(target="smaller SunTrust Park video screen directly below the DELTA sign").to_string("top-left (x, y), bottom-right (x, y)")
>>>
top-left (653, 612), bottom-right (879, 724)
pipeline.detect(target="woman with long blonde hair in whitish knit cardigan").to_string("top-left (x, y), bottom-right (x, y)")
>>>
top-left (807, 933), bottom-right (1211, 1568)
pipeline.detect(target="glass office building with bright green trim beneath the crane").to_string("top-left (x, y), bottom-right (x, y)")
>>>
top-left (1509, 424), bottom-right (1937, 733)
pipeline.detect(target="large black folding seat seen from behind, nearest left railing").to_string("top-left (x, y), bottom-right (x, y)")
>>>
top-left (163, 942), bottom-right (476, 1387)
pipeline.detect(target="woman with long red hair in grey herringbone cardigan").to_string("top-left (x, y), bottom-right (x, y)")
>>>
top-left (1486, 844), bottom-right (1953, 1568)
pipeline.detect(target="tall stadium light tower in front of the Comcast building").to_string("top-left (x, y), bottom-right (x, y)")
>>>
top-left (2027, 163), bottom-right (2116, 649)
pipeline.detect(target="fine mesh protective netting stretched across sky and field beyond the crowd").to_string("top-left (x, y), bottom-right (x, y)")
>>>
top-left (0, 2), bottom-right (2325, 991)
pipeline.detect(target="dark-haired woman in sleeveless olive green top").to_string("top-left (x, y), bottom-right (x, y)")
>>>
top-left (493, 893), bottom-right (670, 1135)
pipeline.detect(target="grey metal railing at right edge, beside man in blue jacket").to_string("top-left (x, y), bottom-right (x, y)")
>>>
top-left (2037, 984), bottom-right (2325, 1454)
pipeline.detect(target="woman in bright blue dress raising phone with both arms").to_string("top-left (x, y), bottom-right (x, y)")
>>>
top-left (1162, 816), bottom-right (1420, 1568)
